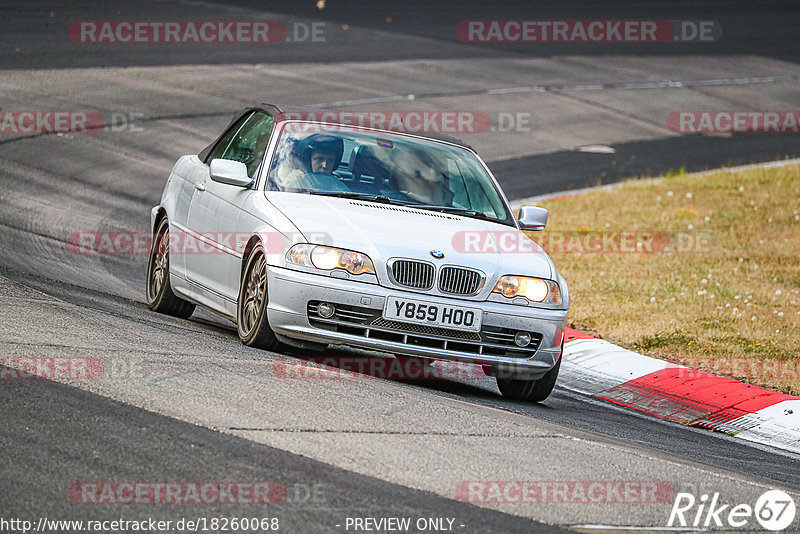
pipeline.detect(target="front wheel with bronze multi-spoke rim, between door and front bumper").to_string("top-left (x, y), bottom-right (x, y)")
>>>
top-left (236, 243), bottom-right (283, 351)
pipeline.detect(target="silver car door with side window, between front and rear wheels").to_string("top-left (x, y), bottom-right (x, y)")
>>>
top-left (185, 111), bottom-right (273, 310)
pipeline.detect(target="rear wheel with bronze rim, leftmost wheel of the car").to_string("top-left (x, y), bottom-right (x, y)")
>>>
top-left (147, 217), bottom-right (194, 319)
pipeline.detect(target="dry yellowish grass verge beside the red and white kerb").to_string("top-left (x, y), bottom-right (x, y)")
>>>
top-left (528, 161), bottom-right (800, 394)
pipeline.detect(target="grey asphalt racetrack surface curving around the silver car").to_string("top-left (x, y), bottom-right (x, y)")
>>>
top-left (0, 0), bottom-right (800, 533)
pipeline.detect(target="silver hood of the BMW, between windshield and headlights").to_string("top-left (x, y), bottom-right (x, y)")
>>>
top-left (268, 192), bottom-right (555, 290)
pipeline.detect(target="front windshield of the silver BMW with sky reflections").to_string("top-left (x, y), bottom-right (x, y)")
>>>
top-left (267, 123), bottom-right (514, 224)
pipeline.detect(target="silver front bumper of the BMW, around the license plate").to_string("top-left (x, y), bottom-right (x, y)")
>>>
top-left (267, 266), bottom-right (567, 379)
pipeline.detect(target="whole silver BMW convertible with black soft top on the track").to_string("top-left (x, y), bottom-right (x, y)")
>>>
top-left (147, 104), bottom-right (569, 402)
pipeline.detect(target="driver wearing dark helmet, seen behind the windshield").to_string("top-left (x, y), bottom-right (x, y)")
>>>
top-left (281, 134), bottom-right (347, 191)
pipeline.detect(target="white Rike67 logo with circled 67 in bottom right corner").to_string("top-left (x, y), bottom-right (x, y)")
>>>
top-left (667, 490), bottom-right (796, 531)
